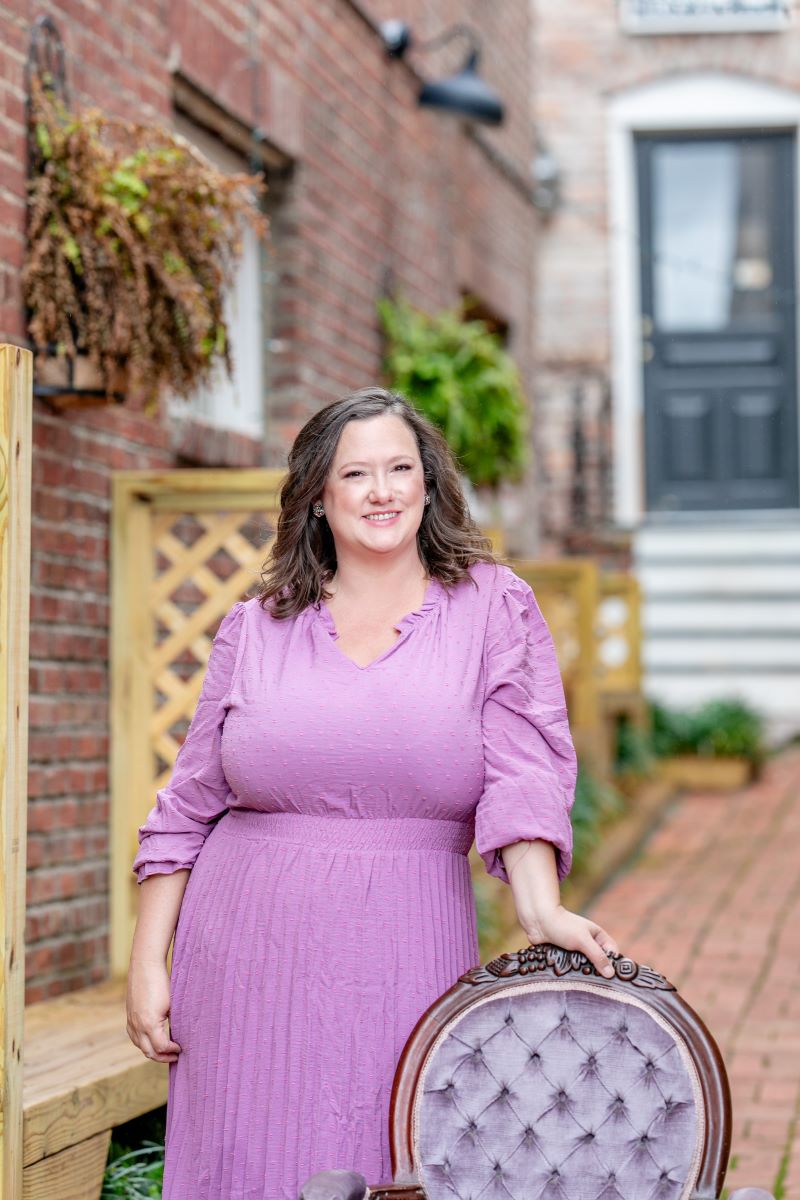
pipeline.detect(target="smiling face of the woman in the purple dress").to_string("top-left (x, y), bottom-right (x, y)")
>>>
top-left (320, 413), bottom-right (425, 558)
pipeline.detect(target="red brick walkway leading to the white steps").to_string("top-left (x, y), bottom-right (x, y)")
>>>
top-left (591, 749), bottom-right (800, 1200)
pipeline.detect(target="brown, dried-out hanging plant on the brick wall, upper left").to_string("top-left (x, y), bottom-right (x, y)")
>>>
top-left (23, 85), bottom-right (266, 406)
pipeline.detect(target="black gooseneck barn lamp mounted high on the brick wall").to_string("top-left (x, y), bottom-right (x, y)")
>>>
top-left (380, 20), bottom-right (505, 125)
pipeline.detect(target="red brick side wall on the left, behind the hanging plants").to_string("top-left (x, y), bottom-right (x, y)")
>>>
top-left (0, 0), bottom-right (535, 1001)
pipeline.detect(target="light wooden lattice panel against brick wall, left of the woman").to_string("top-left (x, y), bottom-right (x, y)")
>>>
top-left (112, 469), bottom-right (283, 972)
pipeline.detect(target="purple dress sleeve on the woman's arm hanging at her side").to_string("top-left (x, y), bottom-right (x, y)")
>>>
top-left (132, 601), bottom-right (245, 883)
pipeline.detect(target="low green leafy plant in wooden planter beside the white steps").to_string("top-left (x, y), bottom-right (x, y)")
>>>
top-left (651, 700), bottom-right (765, 764)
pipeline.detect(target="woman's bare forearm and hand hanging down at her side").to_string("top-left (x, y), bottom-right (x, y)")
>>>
top-left (127, 870), bottom-right (190, 1062)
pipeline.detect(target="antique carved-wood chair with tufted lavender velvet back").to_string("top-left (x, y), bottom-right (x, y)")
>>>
top-left (301, 946), bottom-right (770, 1200)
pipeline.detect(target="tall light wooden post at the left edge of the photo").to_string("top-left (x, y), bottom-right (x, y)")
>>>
top-left (0, 346), bottom-right (32, 1200)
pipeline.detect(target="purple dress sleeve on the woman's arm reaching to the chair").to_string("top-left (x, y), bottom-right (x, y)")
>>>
top-left (475, 568), bottom-right (577, 883)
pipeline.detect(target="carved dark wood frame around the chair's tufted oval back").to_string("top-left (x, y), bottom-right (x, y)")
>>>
top-left (369, 946), bottom-right (732, 1200)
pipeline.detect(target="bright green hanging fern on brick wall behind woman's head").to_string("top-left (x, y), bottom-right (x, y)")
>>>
top-left (378, 299), bottom-right (528, 488)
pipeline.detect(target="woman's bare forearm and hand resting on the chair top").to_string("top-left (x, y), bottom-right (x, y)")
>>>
top-left (500, 840), bottom-right (619, 979)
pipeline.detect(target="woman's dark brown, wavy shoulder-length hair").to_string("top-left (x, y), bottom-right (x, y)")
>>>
top-left (259, 388), bottom-right (497, 619)
